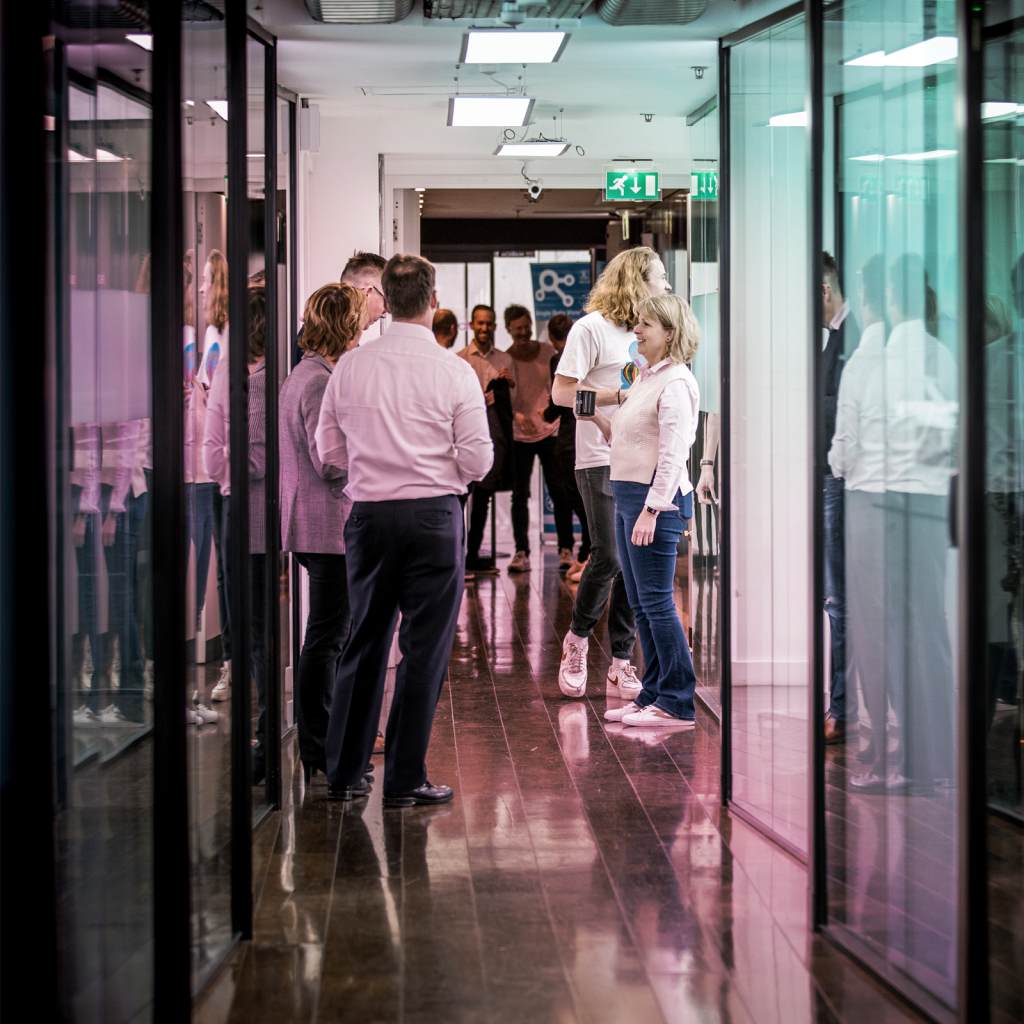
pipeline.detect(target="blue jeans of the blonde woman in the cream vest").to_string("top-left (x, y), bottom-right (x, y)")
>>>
top-left (611, 480), bottom-right (697, 720)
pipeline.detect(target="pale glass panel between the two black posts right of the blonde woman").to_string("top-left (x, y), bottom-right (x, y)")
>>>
top-left (722, 9), bottom-right (810, 857)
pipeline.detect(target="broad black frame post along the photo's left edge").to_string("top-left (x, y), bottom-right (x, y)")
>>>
top-left (0, 3), bottom-right (57, 1020)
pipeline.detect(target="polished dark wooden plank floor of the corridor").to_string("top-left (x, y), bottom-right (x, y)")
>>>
top-left (195, 555), bottom-right (937, 1024)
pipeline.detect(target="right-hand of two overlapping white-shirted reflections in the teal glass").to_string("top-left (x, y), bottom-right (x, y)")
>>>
top-left (851, 254), bottom-right (957, 793)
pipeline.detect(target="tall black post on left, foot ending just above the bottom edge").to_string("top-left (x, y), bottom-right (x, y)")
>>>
top-left (224, 0), bottom-right (253, 939)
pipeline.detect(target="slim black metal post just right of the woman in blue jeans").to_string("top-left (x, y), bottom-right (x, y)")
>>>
top-left (718, 40), bottom-right (732, 805)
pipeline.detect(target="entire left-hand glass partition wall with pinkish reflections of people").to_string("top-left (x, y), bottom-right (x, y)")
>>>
top-left (47, 0), bottom-right (294, 1024)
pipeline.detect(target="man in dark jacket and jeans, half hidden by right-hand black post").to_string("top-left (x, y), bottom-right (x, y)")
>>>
top-left (819, 253), bottom-right (860, 743)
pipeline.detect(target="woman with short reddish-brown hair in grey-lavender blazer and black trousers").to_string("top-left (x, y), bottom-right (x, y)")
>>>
top-left (279, 285), bottom-right (367, 782)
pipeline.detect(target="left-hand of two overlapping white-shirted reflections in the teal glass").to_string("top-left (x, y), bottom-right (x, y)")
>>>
top-left (828, 256), bottom-right (887, 764)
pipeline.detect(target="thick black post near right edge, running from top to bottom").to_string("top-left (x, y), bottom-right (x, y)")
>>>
top-left (953, 0), bottom-right (989, 1024)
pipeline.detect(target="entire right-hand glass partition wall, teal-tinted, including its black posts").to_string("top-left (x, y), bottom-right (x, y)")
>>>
top-left (720, 0), bottom-right (1024, 1024)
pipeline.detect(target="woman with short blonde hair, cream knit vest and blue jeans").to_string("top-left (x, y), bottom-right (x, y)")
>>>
top-left (581, 295), bottom-right (700, 726)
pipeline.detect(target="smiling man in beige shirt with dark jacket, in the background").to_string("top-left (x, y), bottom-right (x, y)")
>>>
top-left (456, 305), bottom-right (512, 572)
